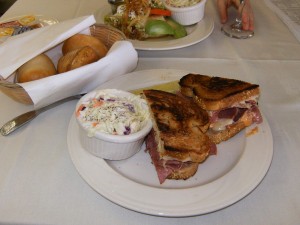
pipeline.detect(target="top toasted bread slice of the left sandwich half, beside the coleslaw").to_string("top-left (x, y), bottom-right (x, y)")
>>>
top-left (143, 90), bottom-right (210, 163)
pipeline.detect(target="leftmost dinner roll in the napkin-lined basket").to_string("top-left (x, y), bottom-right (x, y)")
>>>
top-left (17, 54), bottom-right (56, 83)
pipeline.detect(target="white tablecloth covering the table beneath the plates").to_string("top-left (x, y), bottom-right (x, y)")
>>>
top-left (0, 0), bottom-right (300, 225)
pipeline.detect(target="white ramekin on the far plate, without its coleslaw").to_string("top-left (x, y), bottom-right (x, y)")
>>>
top-left (163, 0), bottom-right (206, 26)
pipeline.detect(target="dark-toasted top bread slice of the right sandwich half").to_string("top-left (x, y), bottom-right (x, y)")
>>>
top-left (179, 74), bottom-right (260, 110)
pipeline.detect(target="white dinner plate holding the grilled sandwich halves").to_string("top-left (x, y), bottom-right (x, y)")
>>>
top-left (67, 69), bottom-right (273, 217)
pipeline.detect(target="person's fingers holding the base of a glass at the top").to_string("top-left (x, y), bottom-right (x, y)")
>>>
top-left (217, 0), bottom-right (254, 30)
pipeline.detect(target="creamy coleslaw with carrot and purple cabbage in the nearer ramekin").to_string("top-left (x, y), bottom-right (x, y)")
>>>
top-left (77, 92), bottom-right (149, 136)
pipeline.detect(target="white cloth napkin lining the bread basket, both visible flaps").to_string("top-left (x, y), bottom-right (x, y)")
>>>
top-left (0, 16), bottom-right (138, 108)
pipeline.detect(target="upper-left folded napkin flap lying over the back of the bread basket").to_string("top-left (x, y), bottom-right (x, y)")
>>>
top-left (0, 15), bottom-right (96, 79)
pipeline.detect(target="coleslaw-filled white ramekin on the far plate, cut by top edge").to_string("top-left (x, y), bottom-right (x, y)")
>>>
top-left (163, 0), bottom-right (206, 26)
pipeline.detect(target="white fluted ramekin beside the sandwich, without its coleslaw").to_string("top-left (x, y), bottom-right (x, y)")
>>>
top-left (75, 89), bottom-right (152, 160)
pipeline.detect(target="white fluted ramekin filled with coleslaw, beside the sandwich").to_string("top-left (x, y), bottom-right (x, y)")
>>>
top-left (75, 89), bottom-right (152, 160)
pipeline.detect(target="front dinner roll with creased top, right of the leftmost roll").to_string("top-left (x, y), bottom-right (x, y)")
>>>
top-left (57, 46), bottom-right (100, 73)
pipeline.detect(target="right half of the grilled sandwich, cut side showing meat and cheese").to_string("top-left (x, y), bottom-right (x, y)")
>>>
top-left (179, 74), bottom-right (262, 144)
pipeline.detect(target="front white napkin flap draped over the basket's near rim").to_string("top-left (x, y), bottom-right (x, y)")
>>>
top-left (20, 41), bottom-right (138, 108)
